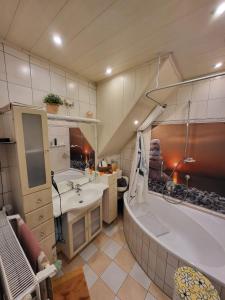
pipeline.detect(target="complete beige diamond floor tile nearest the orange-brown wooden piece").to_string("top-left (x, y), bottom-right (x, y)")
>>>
top-left (88, 251), bottom-right (112, 276)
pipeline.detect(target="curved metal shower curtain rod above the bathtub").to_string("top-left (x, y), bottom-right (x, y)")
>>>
top-left (145, 72), bottom-right (225, 102)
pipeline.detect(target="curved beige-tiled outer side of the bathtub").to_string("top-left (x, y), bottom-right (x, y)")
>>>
top-left (124, 203), bottom-right (225, 300)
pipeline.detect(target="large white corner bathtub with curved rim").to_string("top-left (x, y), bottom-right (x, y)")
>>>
top-left (124, 192), bottom-right (225, 296)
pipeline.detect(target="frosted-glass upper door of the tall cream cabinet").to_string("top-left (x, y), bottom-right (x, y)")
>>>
top-left (13, 106), bottom-right (51, 195)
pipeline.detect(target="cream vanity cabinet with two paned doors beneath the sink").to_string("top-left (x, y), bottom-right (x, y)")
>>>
top-left (60, 200), bottom-right (102, 259)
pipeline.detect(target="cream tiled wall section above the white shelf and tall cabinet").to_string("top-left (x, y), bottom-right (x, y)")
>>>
top-left (0, 44), bottom-right (96, 117)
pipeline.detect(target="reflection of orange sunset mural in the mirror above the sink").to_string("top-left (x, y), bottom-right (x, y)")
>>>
top-left (69, 128), bottom-right (95, 171)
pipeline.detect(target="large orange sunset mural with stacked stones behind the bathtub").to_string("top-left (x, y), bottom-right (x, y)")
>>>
top-left (149, 123), bottom-right (225, 213)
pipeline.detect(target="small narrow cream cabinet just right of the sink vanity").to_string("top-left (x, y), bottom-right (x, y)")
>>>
top-left (98, 172), bottom-right (118, 224)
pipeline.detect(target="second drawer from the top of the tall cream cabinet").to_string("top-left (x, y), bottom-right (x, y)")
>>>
top-left (25, 203), bottom-right (53, 229)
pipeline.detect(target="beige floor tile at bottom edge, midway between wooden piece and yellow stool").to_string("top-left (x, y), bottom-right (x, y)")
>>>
top-left (118, 276), bottom-right (147, 300)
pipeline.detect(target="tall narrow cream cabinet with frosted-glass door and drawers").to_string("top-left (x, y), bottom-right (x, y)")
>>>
top-left (3, 105), bottom-right (56, 261)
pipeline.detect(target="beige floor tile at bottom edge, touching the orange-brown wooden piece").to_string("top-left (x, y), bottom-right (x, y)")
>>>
top-left (90, 278), bottom-right (115, 300)
